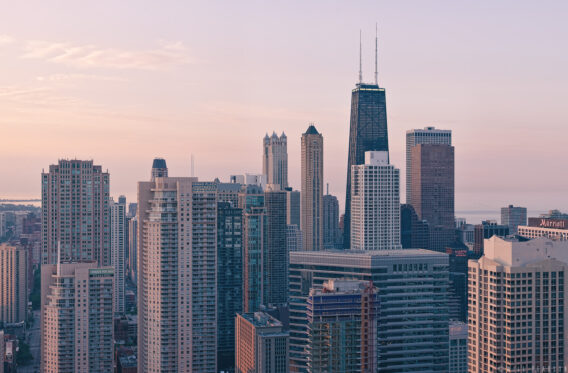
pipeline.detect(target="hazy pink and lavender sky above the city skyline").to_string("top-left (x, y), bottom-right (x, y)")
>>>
top-left (0, 0), bottom-right (568, 215)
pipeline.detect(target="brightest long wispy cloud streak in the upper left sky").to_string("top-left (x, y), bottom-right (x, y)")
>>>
top-left (22, 40), bottom-right (192, 70)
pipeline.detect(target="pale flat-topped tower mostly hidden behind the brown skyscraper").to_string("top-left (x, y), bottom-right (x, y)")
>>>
top-left (406, 127), bottom-right (452, 203)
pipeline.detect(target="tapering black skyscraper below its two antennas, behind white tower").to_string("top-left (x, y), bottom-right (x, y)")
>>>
top-left (343, 83), bottom-right (389, 249)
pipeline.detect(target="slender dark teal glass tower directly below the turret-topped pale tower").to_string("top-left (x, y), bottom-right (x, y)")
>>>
top-left (262, 185), bottom-right (288, 306)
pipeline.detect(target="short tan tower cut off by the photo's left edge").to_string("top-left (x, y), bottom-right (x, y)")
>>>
top-left (0, 243), bottom-right (29, 324)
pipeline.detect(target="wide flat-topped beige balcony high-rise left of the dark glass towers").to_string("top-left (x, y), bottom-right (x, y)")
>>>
top-left (138, 177), bottom-right (217, 372)
